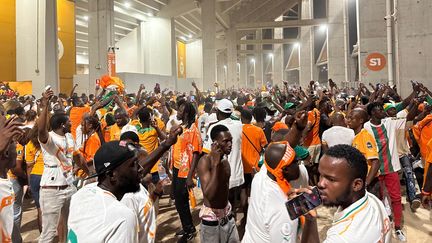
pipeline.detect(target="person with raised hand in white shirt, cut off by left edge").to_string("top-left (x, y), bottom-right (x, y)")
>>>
top-left (0, 112), bottom-right (23, 242)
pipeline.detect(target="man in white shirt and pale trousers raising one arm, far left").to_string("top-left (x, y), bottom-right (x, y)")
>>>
top-left (38, 89), bottom-right (76, 243)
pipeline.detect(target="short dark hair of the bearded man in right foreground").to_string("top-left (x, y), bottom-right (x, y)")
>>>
top-left (325, 144), bottom-right (368, 182)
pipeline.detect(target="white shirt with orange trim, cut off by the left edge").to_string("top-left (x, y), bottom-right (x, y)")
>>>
top-left (0, 178), bottom-right (15, 242)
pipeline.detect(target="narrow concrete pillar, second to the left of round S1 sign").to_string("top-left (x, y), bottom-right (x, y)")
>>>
top-left (300, 0), bottom-right (316, 87)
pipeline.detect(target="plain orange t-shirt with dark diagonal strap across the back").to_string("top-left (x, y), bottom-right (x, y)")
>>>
top-left (241, 124), bottom-right (267, 174)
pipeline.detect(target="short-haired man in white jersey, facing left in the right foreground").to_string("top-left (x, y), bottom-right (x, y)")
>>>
top-left (302, 145), bottom-right (391, 243)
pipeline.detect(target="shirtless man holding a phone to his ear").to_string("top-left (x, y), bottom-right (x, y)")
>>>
top-left (198, 125), bottom-right (240, 242)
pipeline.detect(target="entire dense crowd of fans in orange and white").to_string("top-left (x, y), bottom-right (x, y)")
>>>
top-left (0, 79), bottom-right (432, 243)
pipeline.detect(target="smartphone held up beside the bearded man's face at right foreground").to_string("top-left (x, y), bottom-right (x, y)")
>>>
top-left (285, 187), bottom-right (322, 220)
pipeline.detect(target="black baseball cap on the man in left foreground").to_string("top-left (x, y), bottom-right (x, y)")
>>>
top-left (87, 140), bottom-right (137, 179)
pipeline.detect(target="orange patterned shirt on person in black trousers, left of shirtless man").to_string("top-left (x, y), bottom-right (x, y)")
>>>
top-left (172, 123), bottom-right (202, 178)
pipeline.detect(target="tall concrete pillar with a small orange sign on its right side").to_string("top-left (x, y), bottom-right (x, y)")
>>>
top-left (88, 0), bottom-right (115, 88)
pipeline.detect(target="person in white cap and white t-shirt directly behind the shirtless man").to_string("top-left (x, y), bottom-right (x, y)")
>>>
top-left (203, 99), bottom-right (244, 211)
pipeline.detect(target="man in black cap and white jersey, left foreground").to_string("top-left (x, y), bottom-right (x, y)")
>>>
top-left (68, 141), bottom-right (140, 243)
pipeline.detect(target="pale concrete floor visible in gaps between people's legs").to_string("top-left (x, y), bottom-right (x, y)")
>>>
top-left (22, 189), bottom-right (432, 243)
